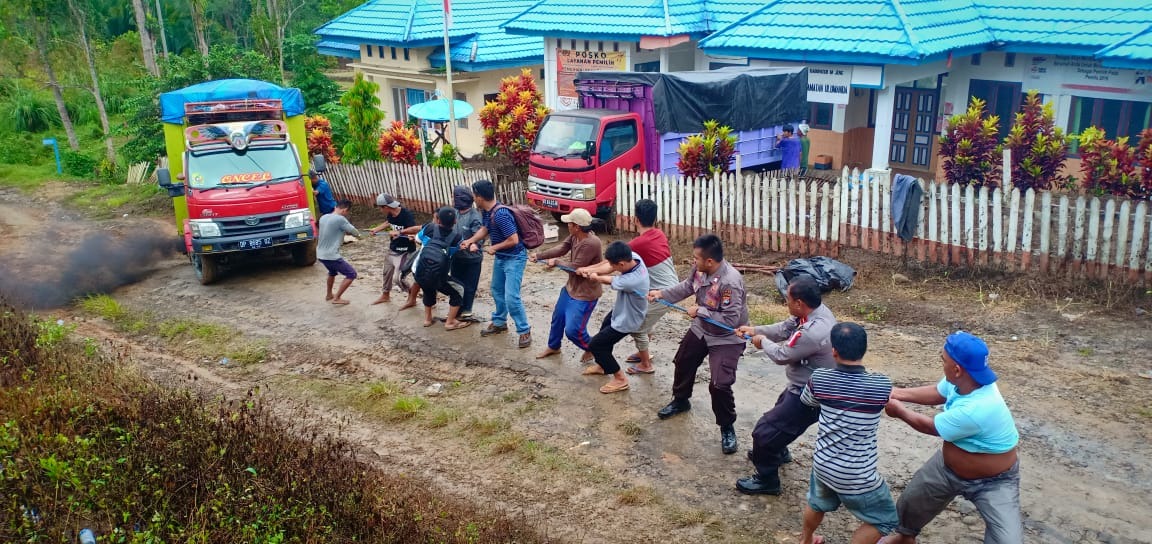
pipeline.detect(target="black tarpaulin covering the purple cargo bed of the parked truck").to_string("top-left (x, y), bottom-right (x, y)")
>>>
top-left (576, 67), bottom-right (809, 134)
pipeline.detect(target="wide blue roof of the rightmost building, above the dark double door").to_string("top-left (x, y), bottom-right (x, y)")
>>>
top-left (700, 0), bottom-right (1152, 67)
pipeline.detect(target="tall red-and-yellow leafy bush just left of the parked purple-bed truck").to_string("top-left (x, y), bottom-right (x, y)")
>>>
top-left (479, 68), bottom-right (550, 166)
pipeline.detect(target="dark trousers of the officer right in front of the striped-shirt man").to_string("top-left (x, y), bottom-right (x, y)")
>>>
top-left (752, 390), bottom-right (820, 475)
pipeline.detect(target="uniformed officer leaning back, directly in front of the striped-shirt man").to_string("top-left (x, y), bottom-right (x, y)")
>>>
top-left (734, 277), bottom-right (836, 494)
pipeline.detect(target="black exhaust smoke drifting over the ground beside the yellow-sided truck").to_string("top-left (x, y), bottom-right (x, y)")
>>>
top-left (0, 233), bottom-right (181, 310)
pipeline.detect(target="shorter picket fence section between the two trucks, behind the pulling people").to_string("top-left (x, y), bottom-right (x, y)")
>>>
top-left (325, 161), bottom-right (525, 213)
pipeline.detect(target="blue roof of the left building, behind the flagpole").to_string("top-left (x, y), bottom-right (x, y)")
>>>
top-left (314, 0), bottom-right (544, 70)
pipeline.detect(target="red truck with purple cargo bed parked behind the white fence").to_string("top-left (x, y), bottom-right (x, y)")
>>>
top-left (526, 68), bottom-right (808, 232)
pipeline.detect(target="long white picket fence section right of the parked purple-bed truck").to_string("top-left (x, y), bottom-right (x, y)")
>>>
top-left (616, 168), bottom-right (1152, 284)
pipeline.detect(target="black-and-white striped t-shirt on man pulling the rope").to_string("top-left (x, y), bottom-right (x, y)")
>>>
top-left (801, 364), bottom-right (892, 494)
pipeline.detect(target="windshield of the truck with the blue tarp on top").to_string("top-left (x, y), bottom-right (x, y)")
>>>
top-left (188, 144), bottom-right (300, 189)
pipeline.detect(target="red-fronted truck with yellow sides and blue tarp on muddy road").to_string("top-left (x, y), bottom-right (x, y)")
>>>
top-left (157, 80), bottom-right (324, 285)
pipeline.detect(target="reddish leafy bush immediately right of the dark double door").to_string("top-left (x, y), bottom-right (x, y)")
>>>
top-left (940, 97), bottom-right (1001, 189)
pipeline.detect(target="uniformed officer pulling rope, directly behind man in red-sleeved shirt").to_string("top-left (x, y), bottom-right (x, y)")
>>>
top-left (649, 234), bottom-right (748, 454)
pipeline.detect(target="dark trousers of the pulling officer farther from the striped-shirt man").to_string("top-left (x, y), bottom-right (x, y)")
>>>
top-left (672, 331), bottom-right (744, 426)
